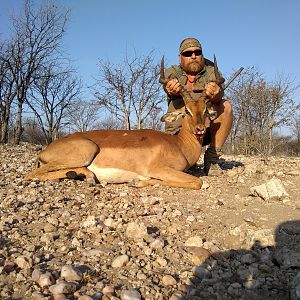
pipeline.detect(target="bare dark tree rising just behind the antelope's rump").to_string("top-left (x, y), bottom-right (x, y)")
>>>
top-left (26, 66), bottom-right (81, 143)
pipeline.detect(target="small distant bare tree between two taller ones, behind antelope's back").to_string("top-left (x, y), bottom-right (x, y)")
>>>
top-left (66, 100), bottom-right (100, 131)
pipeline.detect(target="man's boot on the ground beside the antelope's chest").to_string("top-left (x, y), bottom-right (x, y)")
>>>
top-left (204, 145), bottom-right (223, 176)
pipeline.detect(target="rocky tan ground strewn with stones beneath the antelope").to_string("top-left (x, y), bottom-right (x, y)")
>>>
top-left (0, 144), bottom-right (300, 300)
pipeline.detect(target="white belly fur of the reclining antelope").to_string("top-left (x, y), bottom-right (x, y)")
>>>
top-left (87, 164), bottom-right (149, 183)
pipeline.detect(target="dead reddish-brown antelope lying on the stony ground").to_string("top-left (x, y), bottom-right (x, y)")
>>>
top-left (26, 59), bottom-right (223, 189)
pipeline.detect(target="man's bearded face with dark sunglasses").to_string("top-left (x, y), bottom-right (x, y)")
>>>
top-left (179, 47), bottom-right (204, 75)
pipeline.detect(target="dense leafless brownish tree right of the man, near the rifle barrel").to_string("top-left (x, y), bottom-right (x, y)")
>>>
top-left (227, 68), bottom-right (298, 154)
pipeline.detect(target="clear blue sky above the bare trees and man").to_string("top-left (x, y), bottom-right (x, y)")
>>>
top-left (0, 0), bottom-right (300, 102)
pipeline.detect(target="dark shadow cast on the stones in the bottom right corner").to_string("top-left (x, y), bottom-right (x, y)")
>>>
top-left (180, 220), bottom-right (300, 300)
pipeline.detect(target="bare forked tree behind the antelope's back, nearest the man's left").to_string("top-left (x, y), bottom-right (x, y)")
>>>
top-left (95, 52), bottom-right (165, 129)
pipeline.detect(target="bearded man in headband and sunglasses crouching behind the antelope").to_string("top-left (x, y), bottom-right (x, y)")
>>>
top-left (164, 38), bottom-right (233, 175)
